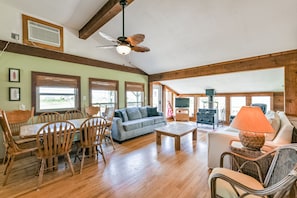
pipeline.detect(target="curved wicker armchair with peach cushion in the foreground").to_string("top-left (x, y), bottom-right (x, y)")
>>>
top-left (209, 144), bottom-right (297, 198)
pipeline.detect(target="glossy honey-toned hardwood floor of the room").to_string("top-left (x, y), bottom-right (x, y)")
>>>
top-left (0, 130), bottom-right (210, 198)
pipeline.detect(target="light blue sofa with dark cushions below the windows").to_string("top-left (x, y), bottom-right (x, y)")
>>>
top-left (112, 107), bottom-right (166, 143)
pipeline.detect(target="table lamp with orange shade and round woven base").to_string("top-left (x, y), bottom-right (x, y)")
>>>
top-left (231, 106), bottom-right (274, 150)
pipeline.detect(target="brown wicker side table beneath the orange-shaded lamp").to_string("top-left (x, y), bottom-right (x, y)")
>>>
top-left (230, 140), bottom-right (274, 180)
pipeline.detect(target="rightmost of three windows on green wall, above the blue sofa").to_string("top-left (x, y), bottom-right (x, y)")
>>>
top-left (125, 82), bottom-right (144, 107)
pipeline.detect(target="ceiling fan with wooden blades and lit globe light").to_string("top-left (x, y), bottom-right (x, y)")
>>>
top-left (98, 0), bottom-right (150, 55)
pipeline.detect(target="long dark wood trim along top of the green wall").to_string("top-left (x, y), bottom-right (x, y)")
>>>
top-left (0, 40), bottom-right (147, 75)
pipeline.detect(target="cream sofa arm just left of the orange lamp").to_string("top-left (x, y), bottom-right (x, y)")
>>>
top-left (207, 131), bottom-right (239, 168)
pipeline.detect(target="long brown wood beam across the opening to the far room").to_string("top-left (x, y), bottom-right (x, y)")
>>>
top-left (149, 49), bottom-right (297, 82)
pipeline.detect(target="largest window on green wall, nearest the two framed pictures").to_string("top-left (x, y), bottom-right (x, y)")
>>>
top-left (32, 72), bottom-right (80, 113)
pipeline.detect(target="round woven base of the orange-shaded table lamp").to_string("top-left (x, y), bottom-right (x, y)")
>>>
top-left (239, 131), bottom-right (265, 151)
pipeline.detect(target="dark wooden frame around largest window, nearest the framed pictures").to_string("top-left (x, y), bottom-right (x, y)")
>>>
top-left (31, 71), bottom-right (81, 115)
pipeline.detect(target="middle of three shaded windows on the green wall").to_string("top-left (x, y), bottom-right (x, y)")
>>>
top-left (89, 78), bottom-right (119, 112)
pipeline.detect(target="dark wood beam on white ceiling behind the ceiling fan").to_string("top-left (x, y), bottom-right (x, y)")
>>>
top-left (79, 0), bottom-right (133, 39)
